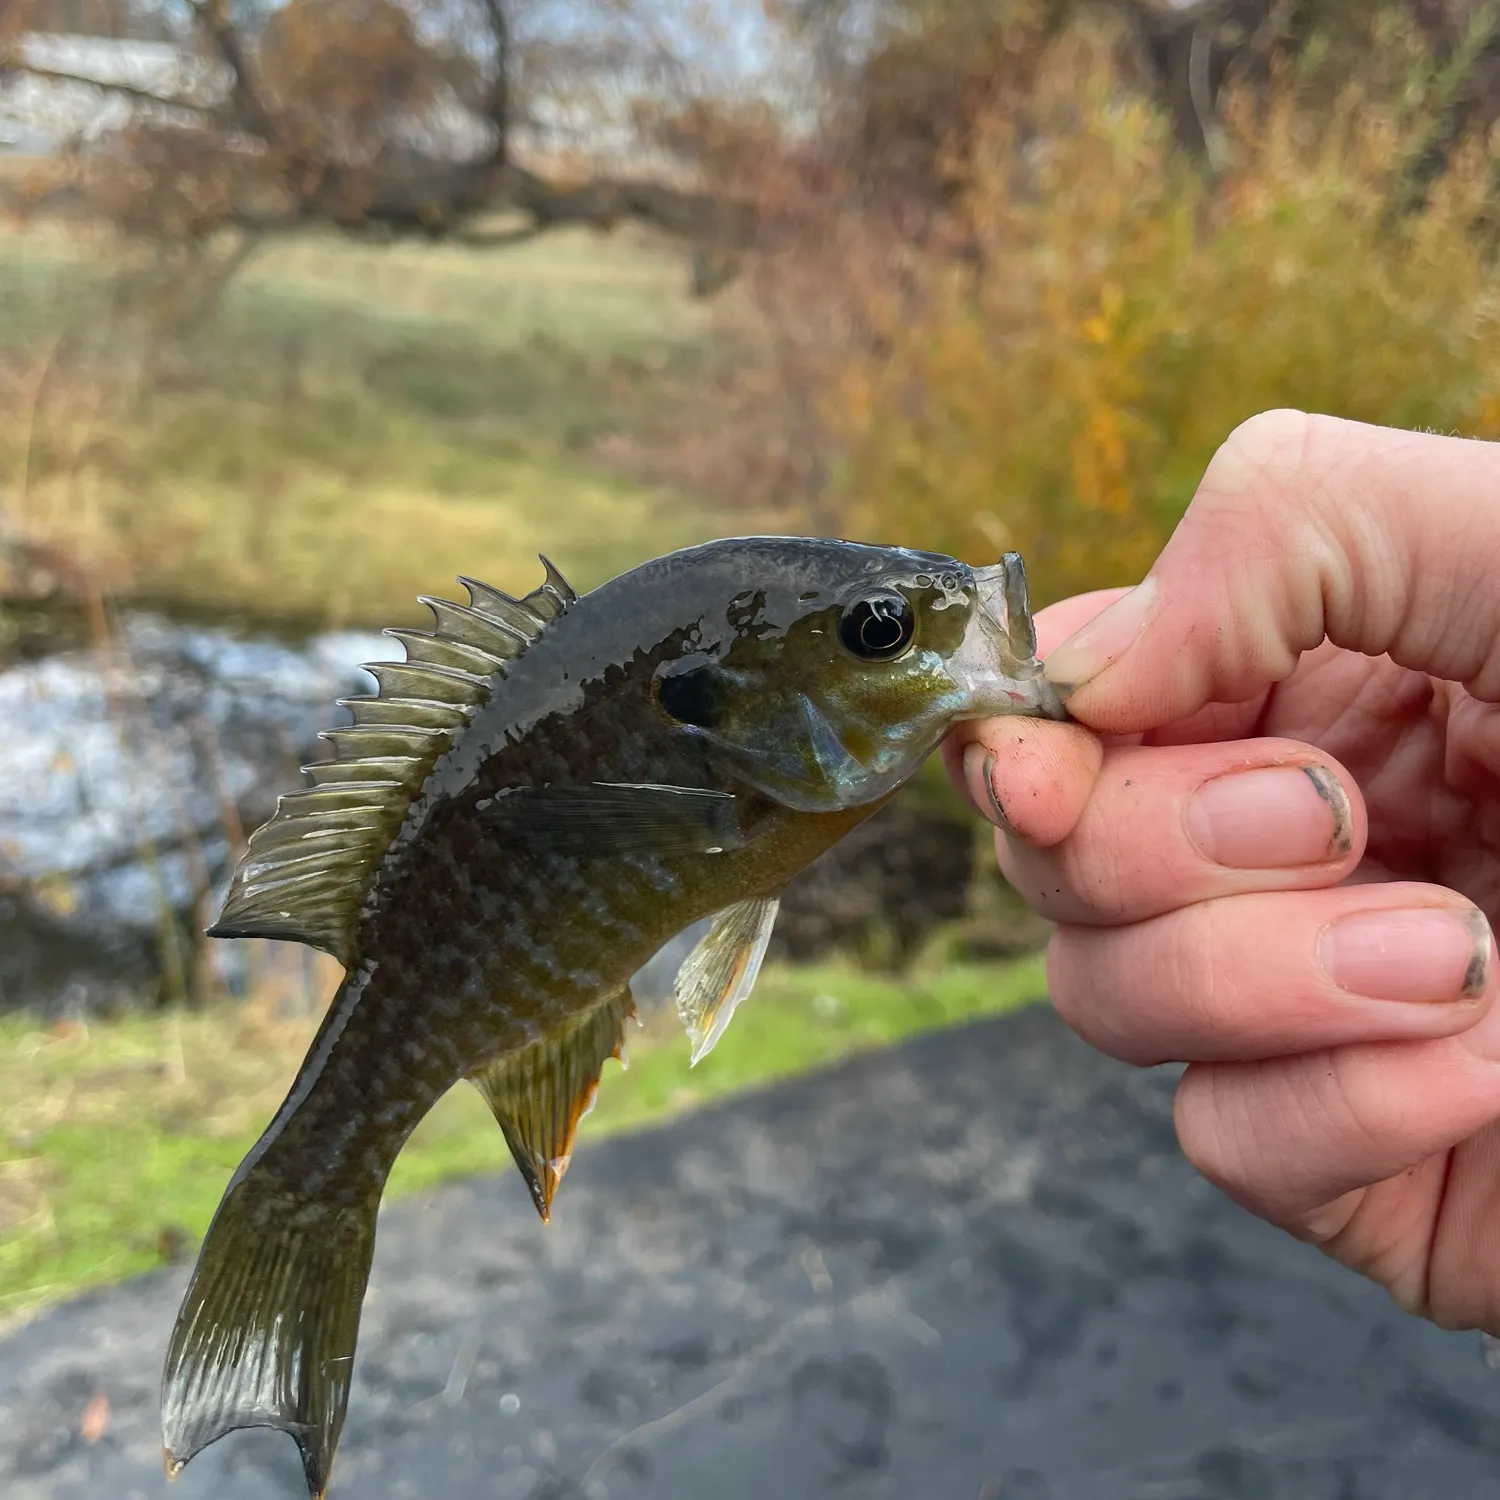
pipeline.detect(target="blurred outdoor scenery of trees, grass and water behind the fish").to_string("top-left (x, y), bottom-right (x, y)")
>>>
top-left (0, 0), bottom-right (1500, 1392)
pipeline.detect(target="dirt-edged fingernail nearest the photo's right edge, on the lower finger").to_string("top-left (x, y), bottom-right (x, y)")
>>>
top-left (1319, 906), bottom-right (1490, 1005)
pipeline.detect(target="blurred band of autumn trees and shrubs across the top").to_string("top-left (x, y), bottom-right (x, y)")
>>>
top-left (0, 0), bottom-right (1500, 615)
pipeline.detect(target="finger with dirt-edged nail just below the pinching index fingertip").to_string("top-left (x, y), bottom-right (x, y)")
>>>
top-left (968, 740), bottom-right (1367, 926)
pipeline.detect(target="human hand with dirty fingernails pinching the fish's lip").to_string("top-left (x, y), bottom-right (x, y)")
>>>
top-left (945, 413), bottom-right (1500, 1335)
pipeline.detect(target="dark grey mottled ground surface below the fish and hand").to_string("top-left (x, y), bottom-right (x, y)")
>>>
top-left (0, 1010), bottom-right (1500, 1500)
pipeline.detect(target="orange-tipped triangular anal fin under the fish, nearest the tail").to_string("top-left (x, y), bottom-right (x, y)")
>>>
top-left (470, 989), bottom-right (636, 1223)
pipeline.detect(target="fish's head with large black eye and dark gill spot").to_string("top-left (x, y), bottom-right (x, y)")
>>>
top-left (656, 539), bottom-right (1067, 812)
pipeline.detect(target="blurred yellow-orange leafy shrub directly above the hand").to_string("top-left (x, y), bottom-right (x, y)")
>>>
top-left (824, 32), bottom-right (1500, 599)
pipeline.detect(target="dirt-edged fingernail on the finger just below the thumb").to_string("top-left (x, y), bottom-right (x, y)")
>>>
top-left (1182, 765), bottom-right (1355, 870)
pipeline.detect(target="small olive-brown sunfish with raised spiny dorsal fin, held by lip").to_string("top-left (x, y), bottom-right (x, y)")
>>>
top-left (161, 537), bottom-right (1067, 1500)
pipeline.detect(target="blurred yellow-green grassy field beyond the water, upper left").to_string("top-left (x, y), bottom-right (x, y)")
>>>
top-left (0, 219), bottom-right (746, 626)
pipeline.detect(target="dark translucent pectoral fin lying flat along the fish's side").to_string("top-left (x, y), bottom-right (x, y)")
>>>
top-left (480, 782), bottom-right (750, 855)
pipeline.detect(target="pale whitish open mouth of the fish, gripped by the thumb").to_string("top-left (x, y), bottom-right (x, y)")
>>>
top-left (948, 552), bottom-right (1068, 720)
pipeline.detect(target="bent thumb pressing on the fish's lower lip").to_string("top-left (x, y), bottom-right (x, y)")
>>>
top-left (1047, 411), bottom-right (1500, 734)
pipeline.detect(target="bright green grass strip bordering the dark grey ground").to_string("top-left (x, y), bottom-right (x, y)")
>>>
top-left (0, 957), bottom-right (1044, 1319)
